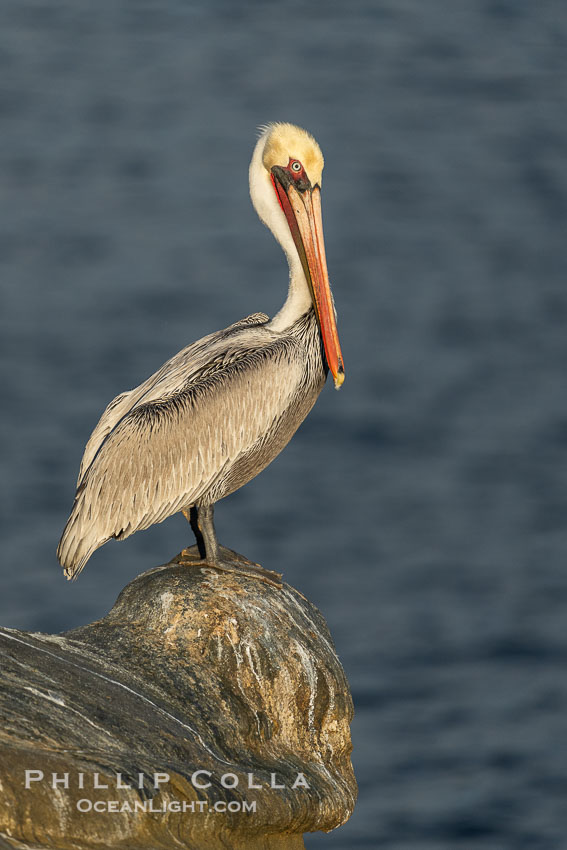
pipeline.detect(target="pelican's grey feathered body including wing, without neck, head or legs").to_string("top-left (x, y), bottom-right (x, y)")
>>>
top-left (57, 309), bottom-right (327, 577)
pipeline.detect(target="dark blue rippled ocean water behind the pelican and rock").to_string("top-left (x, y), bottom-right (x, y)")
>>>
top-left (0, 0), bottom-right (567, 850)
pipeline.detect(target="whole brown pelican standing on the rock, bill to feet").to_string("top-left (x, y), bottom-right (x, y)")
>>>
top-left (57, 124), bottom-right (344, 578)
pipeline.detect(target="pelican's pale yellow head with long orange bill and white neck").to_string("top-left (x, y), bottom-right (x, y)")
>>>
top-left (250, 124), bottom-right (344, 389)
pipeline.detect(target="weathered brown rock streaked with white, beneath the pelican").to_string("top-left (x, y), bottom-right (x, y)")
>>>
top-left (0, 553), bottom-right (356, 850)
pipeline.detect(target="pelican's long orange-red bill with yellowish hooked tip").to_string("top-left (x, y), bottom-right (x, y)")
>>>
top-left (273, 169), bottom-right (345, 389)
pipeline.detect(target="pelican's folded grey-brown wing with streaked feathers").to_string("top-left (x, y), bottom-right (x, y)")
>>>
top-left (58, 314), bottom-right (304, 576)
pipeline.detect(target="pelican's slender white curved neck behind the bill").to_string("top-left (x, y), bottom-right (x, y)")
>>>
top-left (250, 130), bottom-right (312, 331)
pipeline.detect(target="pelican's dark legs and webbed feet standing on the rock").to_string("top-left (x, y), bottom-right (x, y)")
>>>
top-left (181, 505), bottom-right (282, 588)
